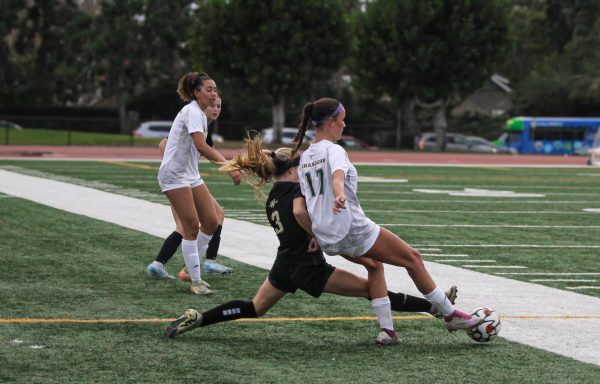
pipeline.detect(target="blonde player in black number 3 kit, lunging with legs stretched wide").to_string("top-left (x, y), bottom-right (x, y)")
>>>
top-left (165, 139), bottom-right (456, 345)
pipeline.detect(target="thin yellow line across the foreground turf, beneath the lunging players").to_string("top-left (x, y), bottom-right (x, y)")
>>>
top-left (0, 315), bottom-right (600, 324)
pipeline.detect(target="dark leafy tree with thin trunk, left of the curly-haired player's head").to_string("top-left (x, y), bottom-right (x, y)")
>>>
top-left (89, 0), bottom-right (192, 133)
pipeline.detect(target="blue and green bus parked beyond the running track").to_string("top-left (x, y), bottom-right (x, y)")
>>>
top-left (497, 117), bottom-right (600, 155)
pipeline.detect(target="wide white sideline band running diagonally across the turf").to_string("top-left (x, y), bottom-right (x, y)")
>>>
top-left (0, 170), bottom-right (600, 365)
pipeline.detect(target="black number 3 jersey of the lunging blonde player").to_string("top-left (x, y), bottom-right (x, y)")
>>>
top-left (266, 181), bottom-right (325, 265)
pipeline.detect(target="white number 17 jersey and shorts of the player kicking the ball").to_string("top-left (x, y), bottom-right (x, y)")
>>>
top-left (298, 140), bottom-right (379, 256)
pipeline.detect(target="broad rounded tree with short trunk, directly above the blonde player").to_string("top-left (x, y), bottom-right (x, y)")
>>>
top-left (192, 0), bottom-right (350, 142)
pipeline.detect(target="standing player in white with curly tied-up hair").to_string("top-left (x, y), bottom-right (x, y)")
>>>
top-left (158, 72), bottom-right (240, 295)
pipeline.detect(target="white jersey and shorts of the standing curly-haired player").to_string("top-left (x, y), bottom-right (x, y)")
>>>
top-left (158, 100), bottom-right (208, 191)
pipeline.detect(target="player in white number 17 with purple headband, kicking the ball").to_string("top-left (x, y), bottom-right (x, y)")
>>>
top-left (295, 98), bottom-right (481, 331)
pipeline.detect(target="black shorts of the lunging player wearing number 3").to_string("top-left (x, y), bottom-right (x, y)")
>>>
top-left (269, 263), bottom-right (335, 297)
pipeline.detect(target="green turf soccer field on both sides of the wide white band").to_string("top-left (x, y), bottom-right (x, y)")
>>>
top-left (0, 160), bottom-right (600, 383)
